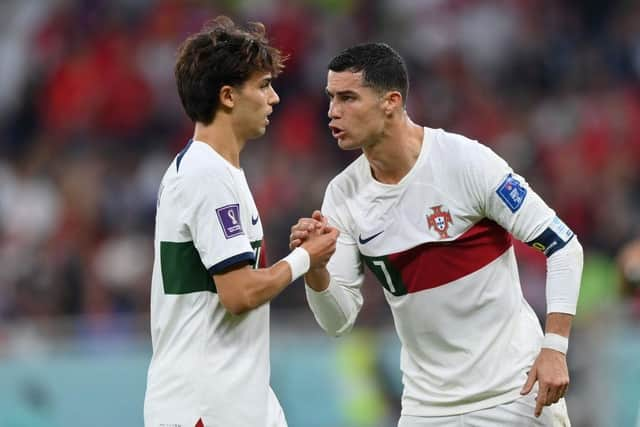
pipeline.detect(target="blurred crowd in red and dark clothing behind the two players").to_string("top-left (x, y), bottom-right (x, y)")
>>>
top-left (0, 0), bottom-right (640, 328)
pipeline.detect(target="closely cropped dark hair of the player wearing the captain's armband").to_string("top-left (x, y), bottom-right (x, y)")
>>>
top-left (329, 43), bottom-right (409, 103)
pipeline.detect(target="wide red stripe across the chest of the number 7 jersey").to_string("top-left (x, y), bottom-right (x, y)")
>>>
top-left (388, 219), bottom-right (511, 293)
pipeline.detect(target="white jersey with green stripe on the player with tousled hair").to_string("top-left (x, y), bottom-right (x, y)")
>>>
top-left (145, 141), bottom-right (286, 427)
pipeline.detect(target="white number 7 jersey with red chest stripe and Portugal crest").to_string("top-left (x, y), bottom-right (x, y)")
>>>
top-left (307, 128), bottom-right (575, 416)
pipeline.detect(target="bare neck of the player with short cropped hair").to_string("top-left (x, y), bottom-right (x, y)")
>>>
top-left (363, 113), bottom-right (424, 184)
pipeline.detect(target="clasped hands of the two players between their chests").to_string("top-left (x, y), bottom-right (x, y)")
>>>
top-left (289, 210), bottom-right (340, 270)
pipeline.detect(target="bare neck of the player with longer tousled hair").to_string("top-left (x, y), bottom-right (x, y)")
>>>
top-left (193, 115), bottom-right (246, 168)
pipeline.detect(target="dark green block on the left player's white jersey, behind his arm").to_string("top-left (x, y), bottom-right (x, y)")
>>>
top-left (160, 242), bottom-right (217, 295)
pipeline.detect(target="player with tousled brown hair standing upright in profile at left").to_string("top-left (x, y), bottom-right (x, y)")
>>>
top-left (144, 17), bottom-right (337, 427)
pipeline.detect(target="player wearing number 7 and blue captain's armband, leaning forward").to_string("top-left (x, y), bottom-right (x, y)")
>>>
top-left (290, 44), bottom-right (582, 427)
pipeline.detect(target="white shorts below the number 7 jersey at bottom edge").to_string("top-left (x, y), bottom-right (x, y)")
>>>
top-left (398, 391), bottom-right (571, 427)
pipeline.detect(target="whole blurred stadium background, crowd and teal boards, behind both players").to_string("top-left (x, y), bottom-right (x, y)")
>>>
top-left (0, 0), bottom-right (640, 427)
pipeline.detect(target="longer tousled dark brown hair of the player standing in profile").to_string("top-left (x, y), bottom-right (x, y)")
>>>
top-left (174, 16), bottom-right (286, 125)
